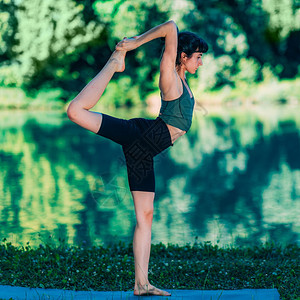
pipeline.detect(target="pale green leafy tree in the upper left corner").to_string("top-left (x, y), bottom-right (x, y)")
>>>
top-left (0, 0), bottom-right (103, 87)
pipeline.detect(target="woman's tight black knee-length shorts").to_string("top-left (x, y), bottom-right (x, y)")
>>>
top-left (97, 114), bottom-right (173, 192)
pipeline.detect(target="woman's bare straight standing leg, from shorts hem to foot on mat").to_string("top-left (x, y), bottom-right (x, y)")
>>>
top-left (131, 191), bottom-right (171, 296)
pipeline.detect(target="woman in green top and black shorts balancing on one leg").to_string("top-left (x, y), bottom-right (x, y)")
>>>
top-left (67, 21), bottom-right (208, 296)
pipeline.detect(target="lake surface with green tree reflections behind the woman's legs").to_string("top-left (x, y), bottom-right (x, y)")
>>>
top-left (0, 108), bottom-right (300, 245)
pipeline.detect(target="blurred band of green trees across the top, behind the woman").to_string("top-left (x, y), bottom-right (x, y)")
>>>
top-left (0, 0), bottom-right (300, 106)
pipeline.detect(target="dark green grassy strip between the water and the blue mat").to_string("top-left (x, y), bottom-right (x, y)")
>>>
top-left (0, 241), bottom-right (300, 300)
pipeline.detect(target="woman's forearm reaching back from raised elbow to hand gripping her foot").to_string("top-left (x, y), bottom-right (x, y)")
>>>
top-left (116, 21), bottom-right (177, 52)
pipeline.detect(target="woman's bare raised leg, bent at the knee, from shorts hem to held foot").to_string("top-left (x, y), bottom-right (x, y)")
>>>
top-left (67, 50), bottom-right (126, 133)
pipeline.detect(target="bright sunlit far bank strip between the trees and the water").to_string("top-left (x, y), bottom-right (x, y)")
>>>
top-left (0, 78), bottom-right (300, 111)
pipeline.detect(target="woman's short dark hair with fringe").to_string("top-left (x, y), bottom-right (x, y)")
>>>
top-left (176, 31), bottom-right (208, 66)
